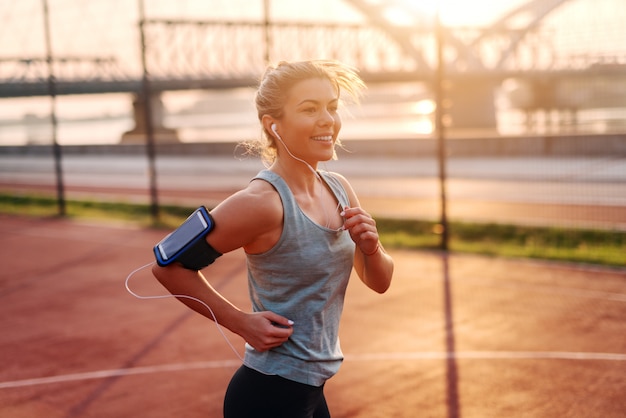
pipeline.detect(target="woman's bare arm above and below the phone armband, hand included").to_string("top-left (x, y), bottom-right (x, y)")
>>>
top-left (152, 181), bottom-right (293, 351)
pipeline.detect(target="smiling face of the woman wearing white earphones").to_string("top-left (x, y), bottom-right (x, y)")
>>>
top-left (277, 78), bottom-right (341, 165)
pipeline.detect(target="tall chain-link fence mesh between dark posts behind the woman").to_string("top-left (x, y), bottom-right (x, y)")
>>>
top-left (0, 0), bottom-right (626, 264)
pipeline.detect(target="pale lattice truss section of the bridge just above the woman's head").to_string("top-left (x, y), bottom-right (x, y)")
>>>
top-left (144, 19), bottom-right (430, 78)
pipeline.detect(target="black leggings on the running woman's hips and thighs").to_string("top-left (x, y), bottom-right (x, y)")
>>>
top-left (224, 366), bottom-right (330, 418)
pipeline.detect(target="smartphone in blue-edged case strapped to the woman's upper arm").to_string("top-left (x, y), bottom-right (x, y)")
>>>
top-left (154, 206), bottom-right (215, 267)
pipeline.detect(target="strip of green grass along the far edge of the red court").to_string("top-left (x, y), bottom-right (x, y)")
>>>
top-left (0, 194), bottom-right (626, 267)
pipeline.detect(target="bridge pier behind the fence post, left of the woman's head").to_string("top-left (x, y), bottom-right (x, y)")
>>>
top-left (121, 93), bottom-right (180, 144)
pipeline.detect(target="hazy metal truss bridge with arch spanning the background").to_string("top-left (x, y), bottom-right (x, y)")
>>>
top-left (0, 0), bottom-right (626, 132)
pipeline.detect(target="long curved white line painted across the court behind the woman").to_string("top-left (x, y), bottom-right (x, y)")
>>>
top-left (0, 351), bottom-right (626, 389)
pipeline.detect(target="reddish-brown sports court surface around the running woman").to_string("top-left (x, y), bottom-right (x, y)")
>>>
top-left (0, 215), bottom-right (626, 418)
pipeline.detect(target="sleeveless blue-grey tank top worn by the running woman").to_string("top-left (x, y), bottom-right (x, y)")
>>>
top-left (245, 170), bottom-right (355, 386)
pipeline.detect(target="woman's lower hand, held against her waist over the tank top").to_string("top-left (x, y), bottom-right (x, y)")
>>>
top-left (239, 311), bottom-right (293, 352)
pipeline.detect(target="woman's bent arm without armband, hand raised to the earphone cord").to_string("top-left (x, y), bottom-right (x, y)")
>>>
top-left (335, 174), bottom-right (393, 293)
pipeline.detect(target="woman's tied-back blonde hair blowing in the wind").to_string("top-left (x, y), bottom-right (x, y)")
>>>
top-left (240, 60), bottom-right (365, 165)
